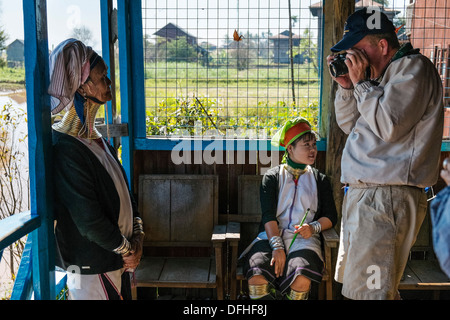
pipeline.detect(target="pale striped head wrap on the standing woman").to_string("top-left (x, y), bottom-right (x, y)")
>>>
top-left (48, 39), bottom-right (101, 123)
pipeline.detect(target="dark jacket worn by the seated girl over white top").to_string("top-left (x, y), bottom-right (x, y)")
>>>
top-left (259, 166), bottom-right (337, 232)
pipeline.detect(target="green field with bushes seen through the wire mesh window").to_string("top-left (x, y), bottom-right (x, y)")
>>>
top-left (145, 62), bottom-right (319, 135)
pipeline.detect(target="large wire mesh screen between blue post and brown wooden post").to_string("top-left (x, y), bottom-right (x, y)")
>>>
top-left (143, 0), bottom-right (321, 138)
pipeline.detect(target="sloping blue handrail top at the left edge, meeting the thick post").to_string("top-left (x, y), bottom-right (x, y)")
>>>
top-left (0, 211), bottom-right (41, 250)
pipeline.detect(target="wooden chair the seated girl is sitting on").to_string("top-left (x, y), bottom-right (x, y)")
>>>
top-left (227, 175), bottom-right (339, 300)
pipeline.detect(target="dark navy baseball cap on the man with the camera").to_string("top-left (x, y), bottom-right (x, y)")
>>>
top-left (331, 7), bottom-right (395, 52)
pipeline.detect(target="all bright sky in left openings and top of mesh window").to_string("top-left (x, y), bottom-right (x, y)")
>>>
top-left (0, 0), bottom-right (324, 51)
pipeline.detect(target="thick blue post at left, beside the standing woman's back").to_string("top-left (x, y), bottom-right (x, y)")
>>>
top-left (23, 0), bottom-right (55, 300)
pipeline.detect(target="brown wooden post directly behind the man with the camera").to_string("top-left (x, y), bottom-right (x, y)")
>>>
top-left (322, 0), bottom-right (355, 224)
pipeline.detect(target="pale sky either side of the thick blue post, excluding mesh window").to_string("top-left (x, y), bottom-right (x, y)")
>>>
top-left (0, 0), bottom-right (101, 51)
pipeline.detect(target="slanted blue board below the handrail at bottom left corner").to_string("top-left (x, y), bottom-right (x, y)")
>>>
top-left (11, 237), bottom-right (32, 300)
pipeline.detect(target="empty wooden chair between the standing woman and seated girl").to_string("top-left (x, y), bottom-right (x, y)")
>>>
top-left (132, 175), bottom-right (226, 300)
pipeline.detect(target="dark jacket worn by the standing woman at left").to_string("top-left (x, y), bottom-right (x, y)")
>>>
top-left (53, 131), bottom-right (138, 274)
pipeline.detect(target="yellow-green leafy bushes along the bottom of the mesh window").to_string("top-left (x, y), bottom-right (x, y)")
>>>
top-left (146, 93), bottom-right (319, 138)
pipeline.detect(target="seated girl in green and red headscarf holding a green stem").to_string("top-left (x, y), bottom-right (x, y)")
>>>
top-left (240, 118), bottom-right (337, 300)
